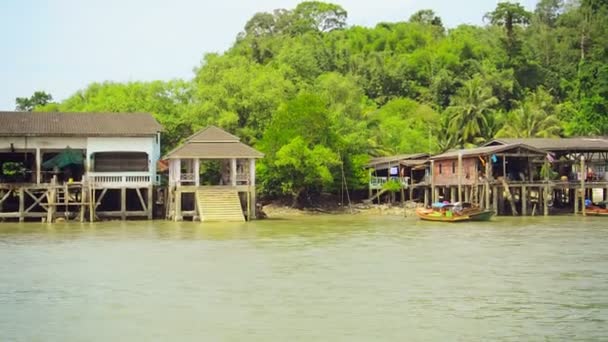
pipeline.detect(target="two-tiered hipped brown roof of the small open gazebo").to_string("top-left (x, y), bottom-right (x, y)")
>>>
top-left (163, 126), bottom-right (264, 159)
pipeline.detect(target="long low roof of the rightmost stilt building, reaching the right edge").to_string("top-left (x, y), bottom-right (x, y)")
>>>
top-left (485, 137), bottom-right (608, 152)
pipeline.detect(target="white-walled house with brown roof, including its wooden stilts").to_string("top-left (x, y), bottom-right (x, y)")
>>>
top-left (0, 112), bottom-right (162, 221)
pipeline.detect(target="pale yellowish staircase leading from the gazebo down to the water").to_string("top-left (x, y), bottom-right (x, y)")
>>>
top-left (196, 187), bottom-right (245, 222)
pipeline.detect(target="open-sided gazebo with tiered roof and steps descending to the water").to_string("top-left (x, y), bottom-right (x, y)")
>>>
top-left (164, 126), bottom-right (264, 221)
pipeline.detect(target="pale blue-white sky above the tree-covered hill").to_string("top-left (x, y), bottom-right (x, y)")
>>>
top-left (0, 0), bottom-right (536, 110)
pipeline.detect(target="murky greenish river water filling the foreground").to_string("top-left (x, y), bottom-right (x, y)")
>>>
top-left (0, 216), bottom-right (608, 341)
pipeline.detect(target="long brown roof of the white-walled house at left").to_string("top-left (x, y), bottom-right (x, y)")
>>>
top-left (0, 112), bottom-right (162, 137)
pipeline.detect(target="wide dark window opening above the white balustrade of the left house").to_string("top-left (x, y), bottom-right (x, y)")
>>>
top-left (93, 152), bottom-right (149, 172)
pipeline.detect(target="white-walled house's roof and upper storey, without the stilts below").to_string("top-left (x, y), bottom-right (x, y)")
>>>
top-left (0, 112), bottom-right (162, 186)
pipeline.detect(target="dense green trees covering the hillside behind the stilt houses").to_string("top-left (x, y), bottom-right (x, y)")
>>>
top-left (32, 0), bottom-right (608, 206)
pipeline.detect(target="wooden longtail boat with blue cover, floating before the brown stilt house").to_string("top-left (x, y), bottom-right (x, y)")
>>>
top-left (416, 203), bottom-right (494, 222)
